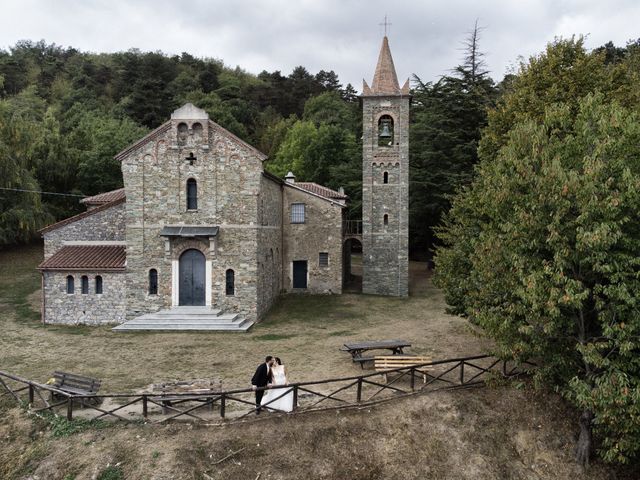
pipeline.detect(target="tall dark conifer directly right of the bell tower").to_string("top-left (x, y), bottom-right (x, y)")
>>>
top-left (409, 23), bottom-right (496, 255)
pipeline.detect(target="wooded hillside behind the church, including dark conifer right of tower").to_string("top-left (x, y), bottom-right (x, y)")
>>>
top-left (0, 31), bottom-right (498, 258)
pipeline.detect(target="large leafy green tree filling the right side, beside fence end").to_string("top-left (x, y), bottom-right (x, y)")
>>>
top-left (436, 62), bottom-right (640, 462)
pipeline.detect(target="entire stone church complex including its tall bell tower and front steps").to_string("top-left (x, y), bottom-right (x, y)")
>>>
top-left (39, 37), bottom-right (410, 331)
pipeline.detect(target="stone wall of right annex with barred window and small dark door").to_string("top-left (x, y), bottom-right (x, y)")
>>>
top-left (282, 184), bottom-right (342, 293)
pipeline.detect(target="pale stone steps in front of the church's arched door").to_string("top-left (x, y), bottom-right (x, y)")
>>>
top-left (112, 307), bottom-right (254, 332)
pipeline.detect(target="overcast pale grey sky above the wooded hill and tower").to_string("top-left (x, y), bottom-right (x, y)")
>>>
top-left (0, 0), bottom-right (640, 91)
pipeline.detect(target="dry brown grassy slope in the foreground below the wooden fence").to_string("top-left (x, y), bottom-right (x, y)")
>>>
top-left (0, 388), bottom-right (632, 480)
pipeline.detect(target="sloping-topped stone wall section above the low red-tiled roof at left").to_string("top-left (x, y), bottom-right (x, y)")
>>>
top-left (43, 203), bottom-right (125, 260)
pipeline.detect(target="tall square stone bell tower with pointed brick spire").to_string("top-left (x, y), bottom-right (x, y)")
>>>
top-left (362, 35), bottom-right (411, 297)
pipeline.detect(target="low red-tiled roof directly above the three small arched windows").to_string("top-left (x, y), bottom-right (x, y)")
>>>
top-left (38, 245), bottom-right (127, 271)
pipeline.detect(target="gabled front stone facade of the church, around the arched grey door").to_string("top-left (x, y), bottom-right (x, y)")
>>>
top-left (122, 110), bottom-right (262, 319)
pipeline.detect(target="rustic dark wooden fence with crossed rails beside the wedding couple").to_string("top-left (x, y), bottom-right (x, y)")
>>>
top-left (0, 355), bottom-right (532, 423)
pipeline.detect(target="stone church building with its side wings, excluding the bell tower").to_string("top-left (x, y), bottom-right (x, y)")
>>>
top-left (39, 104), bottom-right (346, 326)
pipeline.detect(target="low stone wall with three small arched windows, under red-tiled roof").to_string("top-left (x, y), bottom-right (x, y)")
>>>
top-left (43, 271), bottom-right (126, 325)
